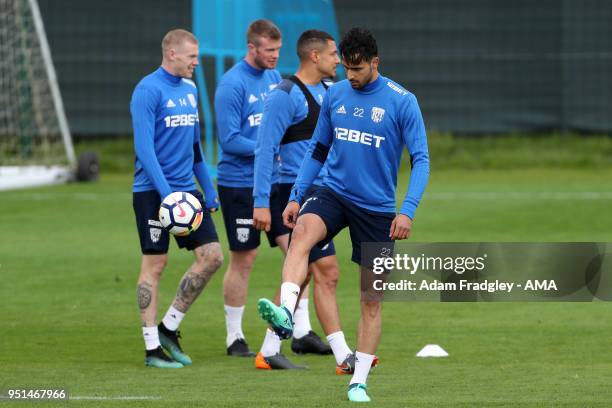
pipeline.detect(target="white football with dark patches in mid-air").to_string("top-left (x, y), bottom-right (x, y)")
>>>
top-left (159, 191), bottom-right (203, 236)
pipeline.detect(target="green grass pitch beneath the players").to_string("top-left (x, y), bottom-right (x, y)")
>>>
top-left (0, 167), bottom-right (612, 407)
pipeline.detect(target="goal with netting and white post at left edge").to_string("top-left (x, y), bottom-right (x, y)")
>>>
top-left (0, 0), bottom-right (76, 190)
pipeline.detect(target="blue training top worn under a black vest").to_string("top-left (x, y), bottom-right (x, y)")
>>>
top-left (253, 79), bottom-right (326, 208)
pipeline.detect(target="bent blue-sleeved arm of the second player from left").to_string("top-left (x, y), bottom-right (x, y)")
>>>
top-left (215, 83), bottom-right (255, 157)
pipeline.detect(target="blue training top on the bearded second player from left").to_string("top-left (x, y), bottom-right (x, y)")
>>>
top-left (215, 60), bottom-right (282, 187)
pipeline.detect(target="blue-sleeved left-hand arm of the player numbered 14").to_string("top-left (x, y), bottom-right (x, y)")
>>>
top-left (130, 87), bottom-right (172, 199)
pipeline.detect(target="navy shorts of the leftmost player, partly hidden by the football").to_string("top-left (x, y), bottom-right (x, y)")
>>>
top-left (132, 190), bottom-right (219, 255)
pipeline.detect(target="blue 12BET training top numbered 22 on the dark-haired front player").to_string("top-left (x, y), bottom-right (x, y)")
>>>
top-left (290, 75), bottom-right (429, 218)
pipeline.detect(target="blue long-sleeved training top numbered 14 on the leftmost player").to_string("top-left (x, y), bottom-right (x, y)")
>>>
top-left (130, 67), bottom-right (217, 208)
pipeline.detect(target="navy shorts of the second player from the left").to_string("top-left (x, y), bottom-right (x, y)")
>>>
top-left (217, 184), bottom-right (288, 251)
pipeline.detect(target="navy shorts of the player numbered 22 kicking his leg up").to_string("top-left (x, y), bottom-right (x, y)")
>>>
top-left (299, 187), bottom-right (395, 269)
